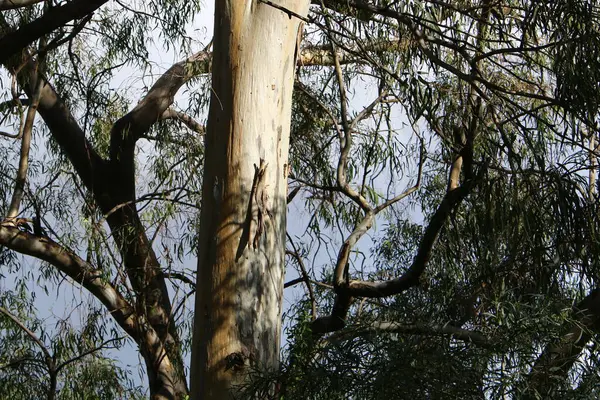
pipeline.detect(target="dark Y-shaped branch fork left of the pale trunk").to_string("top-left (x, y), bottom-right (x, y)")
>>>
top-left (0, 18), bottom-right (210, 392)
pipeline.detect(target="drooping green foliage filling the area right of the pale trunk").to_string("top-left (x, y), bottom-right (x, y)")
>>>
top-left (278, 2), bottom-right (600, 399)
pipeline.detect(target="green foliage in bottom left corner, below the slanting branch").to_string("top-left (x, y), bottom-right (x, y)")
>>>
top-left (0, 286), bottom-right (144, 400)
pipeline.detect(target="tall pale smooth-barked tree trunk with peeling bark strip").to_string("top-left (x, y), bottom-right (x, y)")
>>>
top-left (191, 0), bottom-right (309, 400)
